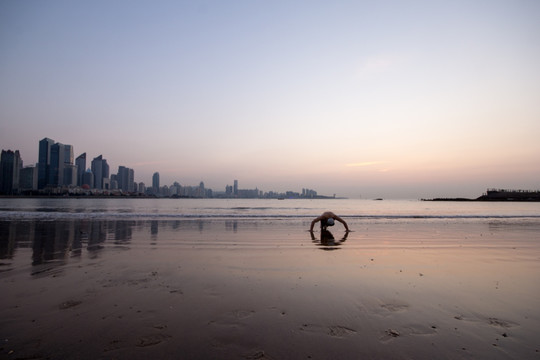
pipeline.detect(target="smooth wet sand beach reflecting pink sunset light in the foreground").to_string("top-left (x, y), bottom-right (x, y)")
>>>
top-left (0, 219), bottom-right (540, 359)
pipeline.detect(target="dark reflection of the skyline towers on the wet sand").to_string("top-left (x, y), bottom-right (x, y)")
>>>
top-left (0, 219), bottom-right (268, 274)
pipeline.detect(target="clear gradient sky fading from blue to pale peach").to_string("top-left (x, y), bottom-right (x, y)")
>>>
top-left (0, 0), bottom-right (540, 198)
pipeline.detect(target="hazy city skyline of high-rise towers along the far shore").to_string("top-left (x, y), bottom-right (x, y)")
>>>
top-left (0, 138), bottom-right (330, 198)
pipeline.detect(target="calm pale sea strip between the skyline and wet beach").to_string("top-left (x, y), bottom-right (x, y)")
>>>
top-left (0, 198), bottom-right (540, 221)
